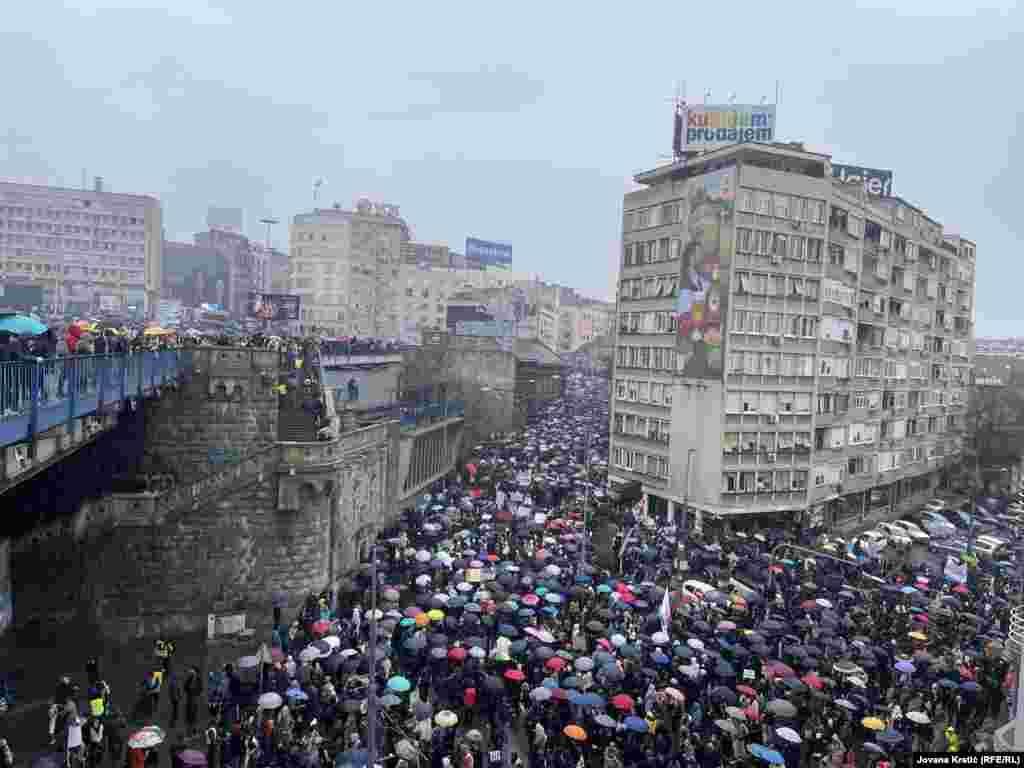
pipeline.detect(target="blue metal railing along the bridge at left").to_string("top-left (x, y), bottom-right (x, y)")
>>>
top-left (0, 349), bottom-right (191, 445)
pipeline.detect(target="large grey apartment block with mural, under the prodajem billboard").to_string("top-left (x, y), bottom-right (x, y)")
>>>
top-left (609, 144), bottom-right (976, 528)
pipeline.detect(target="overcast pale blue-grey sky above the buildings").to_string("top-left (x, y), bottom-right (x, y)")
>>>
top-left (0, 0), bottom-right (1024, 335)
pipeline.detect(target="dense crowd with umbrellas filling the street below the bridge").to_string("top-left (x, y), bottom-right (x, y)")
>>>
top-left (0, 376), bottom-right (1019, 768)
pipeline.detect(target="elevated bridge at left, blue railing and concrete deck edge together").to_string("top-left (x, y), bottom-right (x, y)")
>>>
top-left (0, 349), bottom-right (191, 492)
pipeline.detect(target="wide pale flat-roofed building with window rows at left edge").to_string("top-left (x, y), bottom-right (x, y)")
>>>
top-left (0, 179), bottom-right (163, 316)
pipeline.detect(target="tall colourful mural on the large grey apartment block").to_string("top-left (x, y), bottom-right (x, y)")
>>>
top-left (676, 165), bottom-right (736, 379)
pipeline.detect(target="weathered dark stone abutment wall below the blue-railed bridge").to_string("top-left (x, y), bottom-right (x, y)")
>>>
top-left (0, 347), bottom-right (462, 638)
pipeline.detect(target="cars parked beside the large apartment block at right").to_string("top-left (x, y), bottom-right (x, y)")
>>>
top-left (823, 489), bottom-right (1024, 561)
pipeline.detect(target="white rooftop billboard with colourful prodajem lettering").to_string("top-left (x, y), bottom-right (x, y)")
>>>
top-left (676, 104), bottom-right (775, 152)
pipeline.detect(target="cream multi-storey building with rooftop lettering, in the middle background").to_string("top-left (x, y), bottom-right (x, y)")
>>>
top-left (289, 200), bottom-right (410, 338)
